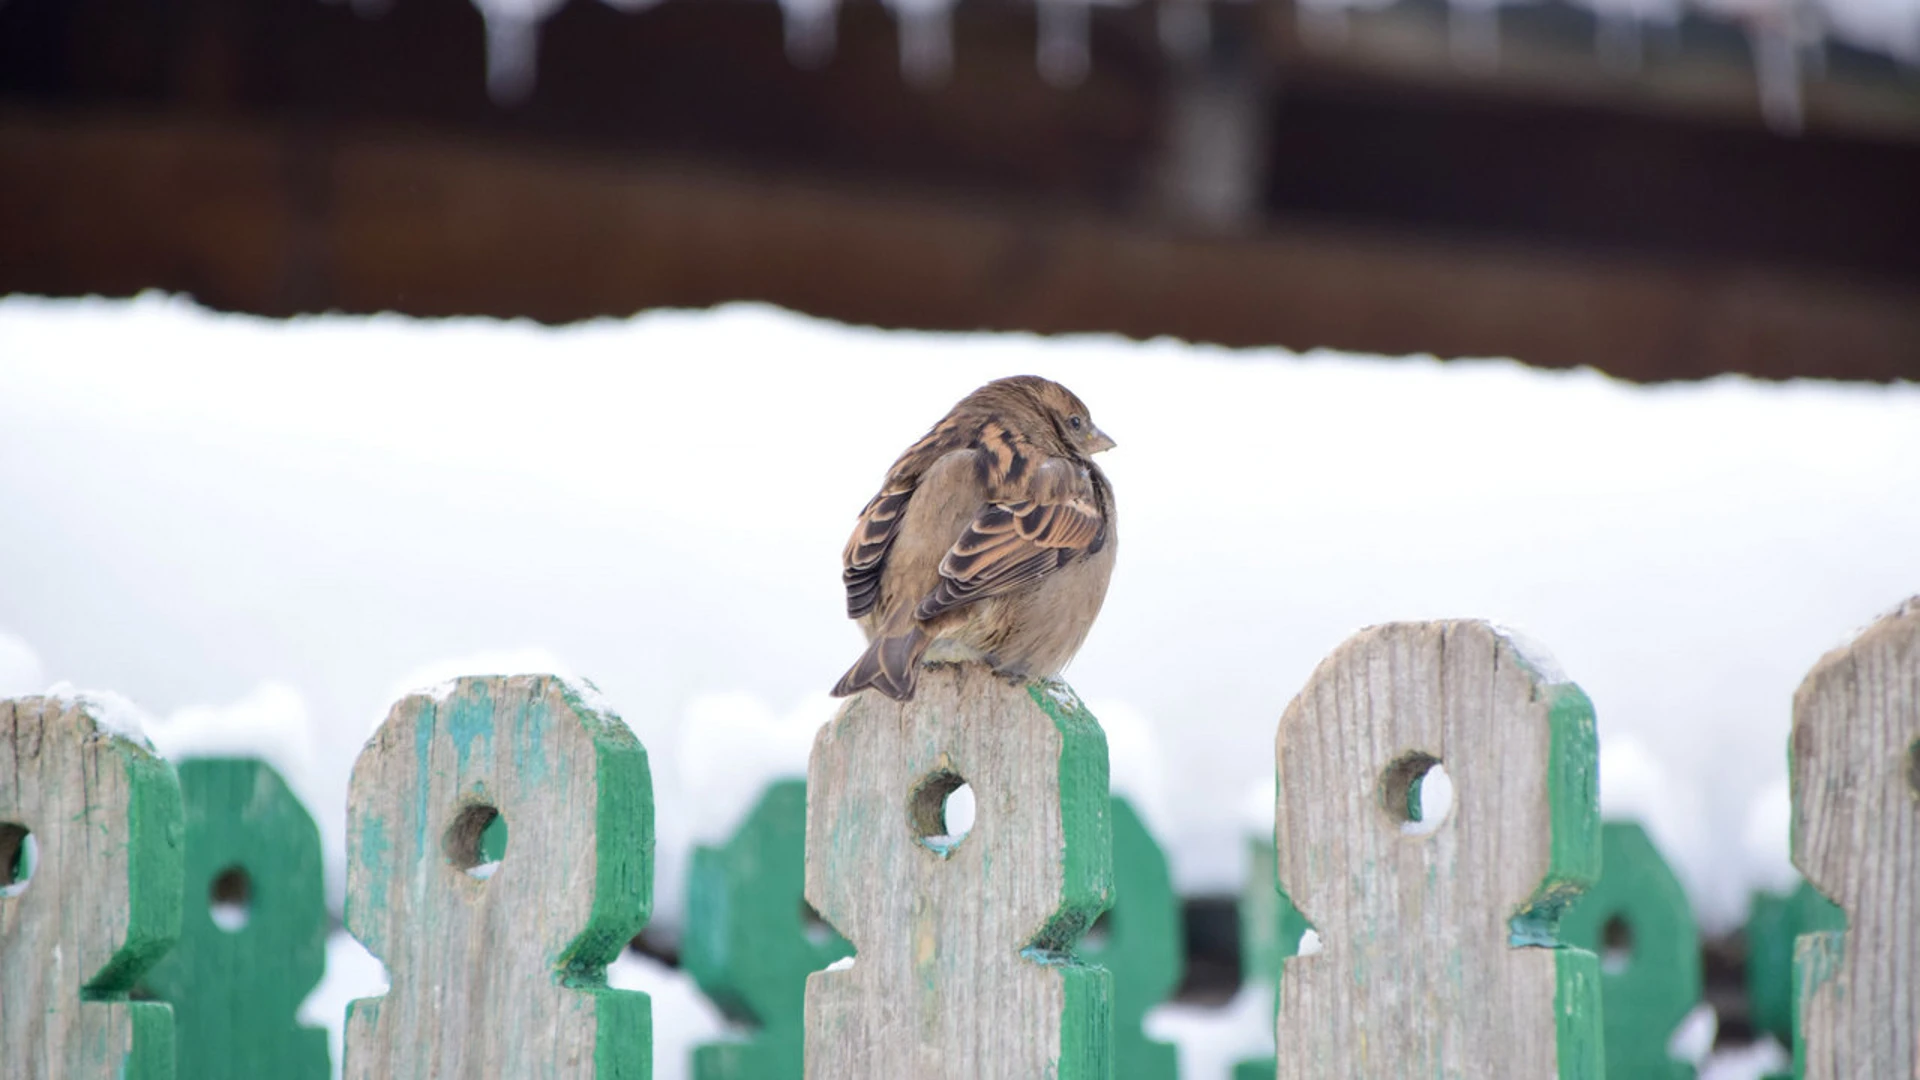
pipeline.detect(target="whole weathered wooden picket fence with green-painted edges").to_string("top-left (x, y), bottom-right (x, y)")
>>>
top-left (0, 598), bottom-right (1920, 1080)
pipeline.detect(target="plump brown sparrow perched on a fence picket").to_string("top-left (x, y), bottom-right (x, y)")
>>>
top-left (833, 375), bottom-right (1117, 701)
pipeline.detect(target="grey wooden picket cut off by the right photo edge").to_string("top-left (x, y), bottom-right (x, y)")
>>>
top-left (1791, 598), bottom-right (1920, 1080)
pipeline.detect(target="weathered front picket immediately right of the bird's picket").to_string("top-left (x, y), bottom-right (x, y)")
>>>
top-left (1275, 623), bottom-right (1603, 1080)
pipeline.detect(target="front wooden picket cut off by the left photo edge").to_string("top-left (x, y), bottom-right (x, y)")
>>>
top-left (0, 698), bottom-right (182, 1080)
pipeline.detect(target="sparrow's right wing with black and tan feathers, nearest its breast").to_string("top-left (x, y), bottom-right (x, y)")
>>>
top-left (914, 457), bottom-right (1106, 621)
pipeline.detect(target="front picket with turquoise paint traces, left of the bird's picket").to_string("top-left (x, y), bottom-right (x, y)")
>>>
top-left (344, 675), bottom-right (653, 1080)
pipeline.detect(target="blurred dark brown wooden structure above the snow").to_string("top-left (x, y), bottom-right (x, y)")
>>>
top-left (0, 0), bottom-right (1920, 380)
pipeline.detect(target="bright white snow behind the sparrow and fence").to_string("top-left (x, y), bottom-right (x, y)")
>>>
top-left (0, 296), bottom-right (1920, 1080)
